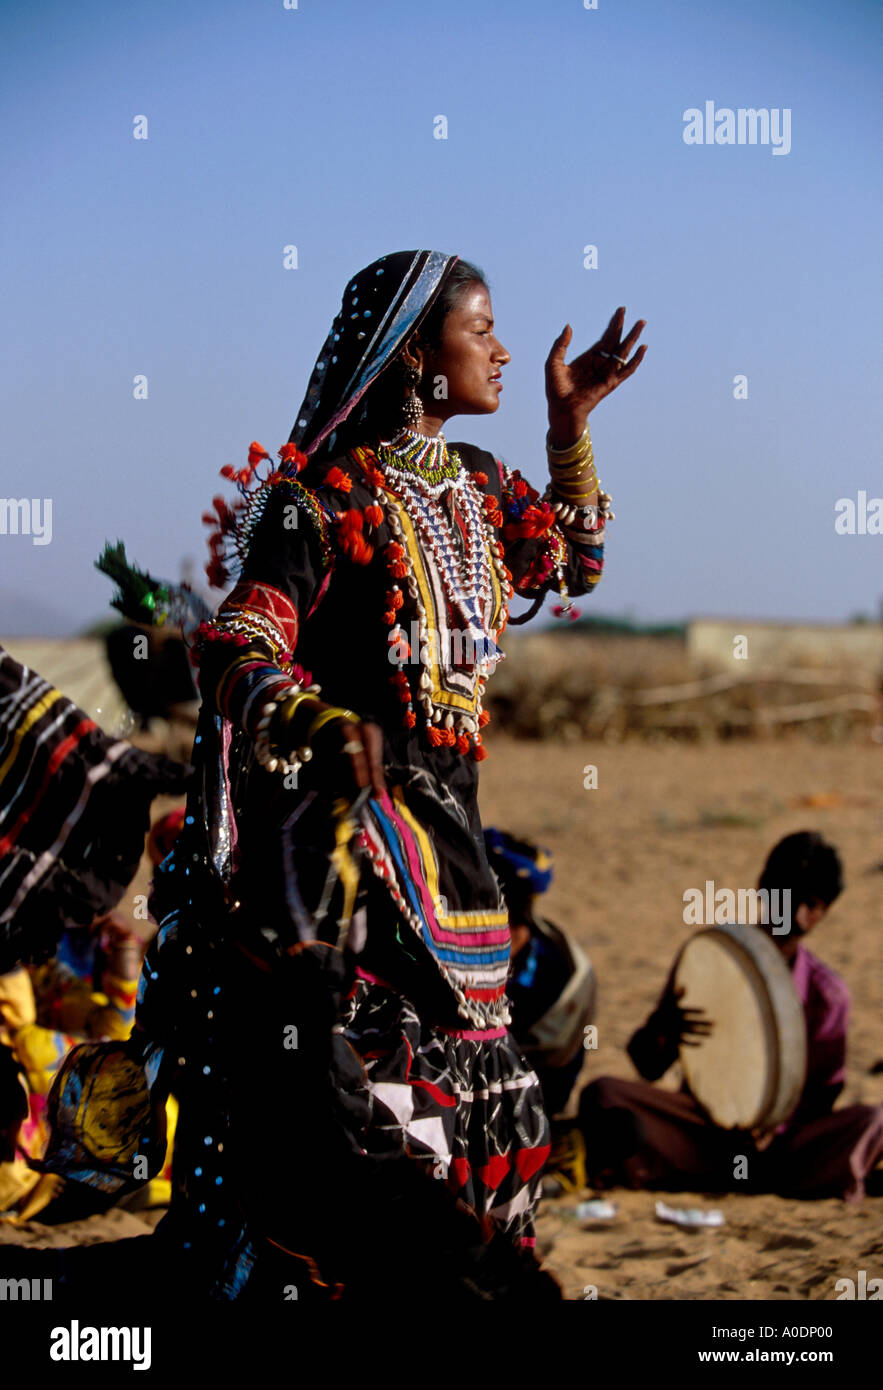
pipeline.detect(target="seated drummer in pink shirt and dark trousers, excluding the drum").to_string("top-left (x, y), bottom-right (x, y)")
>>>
top-left (578, 831), bottom-right (883, 1202)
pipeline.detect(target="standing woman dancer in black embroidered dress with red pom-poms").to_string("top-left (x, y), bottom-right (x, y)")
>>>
top-left (44, 252), bottom-right (645, 1301)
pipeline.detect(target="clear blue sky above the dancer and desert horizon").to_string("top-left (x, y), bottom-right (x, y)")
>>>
top-left (0, 0), bottom-right (883, 635)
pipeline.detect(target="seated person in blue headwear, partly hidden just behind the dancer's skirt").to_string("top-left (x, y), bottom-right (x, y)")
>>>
top-left (484, 828), bottom-right (597, 1115)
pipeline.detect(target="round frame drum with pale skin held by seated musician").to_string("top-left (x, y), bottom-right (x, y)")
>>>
top-left (673, 926), bottom-right (807, 1130)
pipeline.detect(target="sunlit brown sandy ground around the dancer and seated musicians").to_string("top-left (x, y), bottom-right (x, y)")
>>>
top-left (0, 726), bottom-right (883, 1300)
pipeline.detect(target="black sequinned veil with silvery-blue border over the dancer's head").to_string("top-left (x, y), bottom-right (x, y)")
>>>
top-left (289, 252), bottom-right (459, 455)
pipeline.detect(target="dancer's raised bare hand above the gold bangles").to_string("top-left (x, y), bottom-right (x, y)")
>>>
top-left (545, 309), bottom-right (647, 449)
